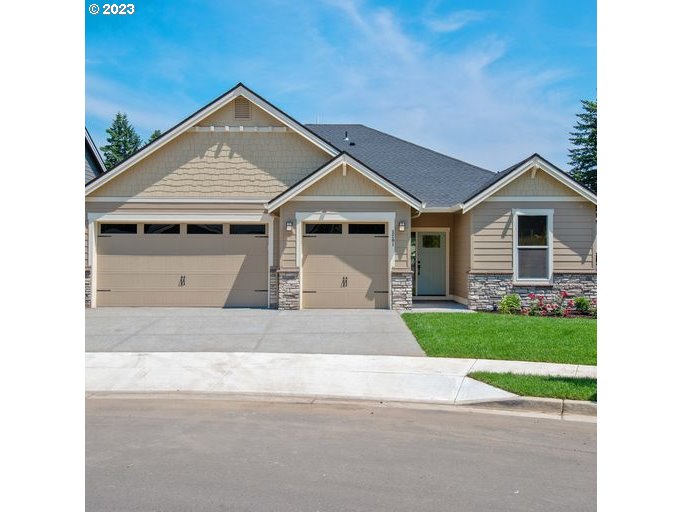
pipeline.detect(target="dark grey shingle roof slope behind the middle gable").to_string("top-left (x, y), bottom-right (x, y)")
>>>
top-left (306, 124), bottom-right (496, 207)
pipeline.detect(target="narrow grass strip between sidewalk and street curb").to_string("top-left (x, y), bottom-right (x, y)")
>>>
top-left (469, 372), bottom-right (597, 402)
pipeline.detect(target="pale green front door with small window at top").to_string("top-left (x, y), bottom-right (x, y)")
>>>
top-left (414, 231), bottom-right (447, 296)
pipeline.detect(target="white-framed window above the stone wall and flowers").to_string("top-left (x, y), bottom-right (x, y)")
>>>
top-left (512, 209), bottom-right (554, 283)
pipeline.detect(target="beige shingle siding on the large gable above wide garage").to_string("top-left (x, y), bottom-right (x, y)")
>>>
top-left (92, 132), bottom-right (329, 198)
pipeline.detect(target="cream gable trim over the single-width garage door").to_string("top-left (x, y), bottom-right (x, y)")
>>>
top-left (268, 151), bottom-right (424, 212)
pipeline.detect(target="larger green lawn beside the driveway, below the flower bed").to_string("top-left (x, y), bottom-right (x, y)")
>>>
top-left (402, 313), bottom-right (597, 365)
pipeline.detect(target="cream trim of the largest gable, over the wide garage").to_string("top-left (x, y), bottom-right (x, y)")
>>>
top-left (85, 82), bottom-right (340, 195)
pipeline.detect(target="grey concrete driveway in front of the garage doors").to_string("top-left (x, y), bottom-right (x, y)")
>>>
top-left (85, 308), bottom-right (424, 356)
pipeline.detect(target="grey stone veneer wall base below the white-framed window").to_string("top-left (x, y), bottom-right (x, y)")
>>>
top-left (468, 273), bottom-right (597, 311)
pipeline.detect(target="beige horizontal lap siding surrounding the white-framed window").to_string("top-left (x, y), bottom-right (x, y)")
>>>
top-left (470, 201), bottom-right (596, 273)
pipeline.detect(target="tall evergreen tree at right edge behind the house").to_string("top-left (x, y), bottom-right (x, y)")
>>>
top-left (568, 100), bottom-right (597, 193)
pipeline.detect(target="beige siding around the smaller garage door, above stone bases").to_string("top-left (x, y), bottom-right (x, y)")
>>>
top-left (276, 200), bottom-right (411, 269)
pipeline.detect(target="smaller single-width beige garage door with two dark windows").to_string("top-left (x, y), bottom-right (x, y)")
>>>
top-left (303, 223), bottom-right (388, 309)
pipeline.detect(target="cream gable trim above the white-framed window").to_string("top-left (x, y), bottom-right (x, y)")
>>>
top-left (462, 153), bottom-right (597, 213)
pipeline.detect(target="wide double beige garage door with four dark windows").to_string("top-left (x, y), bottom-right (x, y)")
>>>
top-left (97, 224), bottom-right (268, 307)
